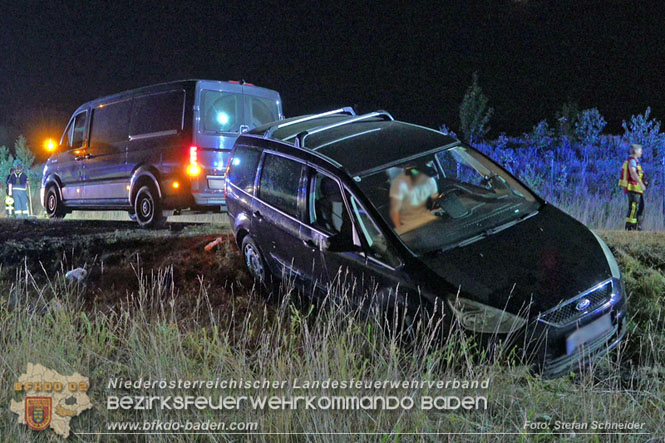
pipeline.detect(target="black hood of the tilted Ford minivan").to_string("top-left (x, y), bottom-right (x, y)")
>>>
top-left (422, 205), bottom-right (611, 316)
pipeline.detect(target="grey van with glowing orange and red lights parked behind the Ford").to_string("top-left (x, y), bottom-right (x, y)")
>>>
top-left (42, 80), bottom-right (283, 227)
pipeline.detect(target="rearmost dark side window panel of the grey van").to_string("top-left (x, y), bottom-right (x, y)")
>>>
top-left (129, 90), bottom-right (185, 135)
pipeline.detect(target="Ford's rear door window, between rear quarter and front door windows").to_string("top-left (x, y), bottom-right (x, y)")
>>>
top-left (259, 154), bottom-right (302, 217)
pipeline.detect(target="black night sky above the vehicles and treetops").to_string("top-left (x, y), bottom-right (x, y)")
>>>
top-left (0, 0), bottom-right (665, 158)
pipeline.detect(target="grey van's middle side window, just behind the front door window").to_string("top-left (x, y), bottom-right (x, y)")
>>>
top-left (90, 100), bottom-right (131, 147)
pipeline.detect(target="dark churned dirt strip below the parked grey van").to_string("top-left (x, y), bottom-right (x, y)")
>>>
top-left (0, 219), bottom-right (252, 316)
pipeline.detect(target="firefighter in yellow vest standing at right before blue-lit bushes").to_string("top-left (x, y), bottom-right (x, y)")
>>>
top-left (619, 144), bottom-right (647, 231)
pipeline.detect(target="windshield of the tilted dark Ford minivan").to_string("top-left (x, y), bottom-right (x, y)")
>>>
top-left (358, 145), bottom-right (539, 255)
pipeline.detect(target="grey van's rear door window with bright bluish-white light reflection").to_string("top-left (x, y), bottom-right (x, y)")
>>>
top-left (200, 90), bottom-right (243, 132)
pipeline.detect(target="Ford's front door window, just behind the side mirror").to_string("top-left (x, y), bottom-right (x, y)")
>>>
top-left (307, 172), bottom-right (353, 238)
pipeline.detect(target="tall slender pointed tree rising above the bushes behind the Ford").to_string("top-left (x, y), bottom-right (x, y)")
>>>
top-left (459, 72), bottom-right (494, 143)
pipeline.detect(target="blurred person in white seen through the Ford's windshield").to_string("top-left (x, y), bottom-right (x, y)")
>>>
top-left (390, 164), bottom-right (438, 234)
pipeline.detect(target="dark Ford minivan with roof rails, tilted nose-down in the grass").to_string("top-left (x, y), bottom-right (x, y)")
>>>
top-left (226, 109), bottom-right (626, 377)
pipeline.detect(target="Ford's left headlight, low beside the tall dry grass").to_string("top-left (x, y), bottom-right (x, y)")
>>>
top-left (446, 296), bottom-right (527, 334)
